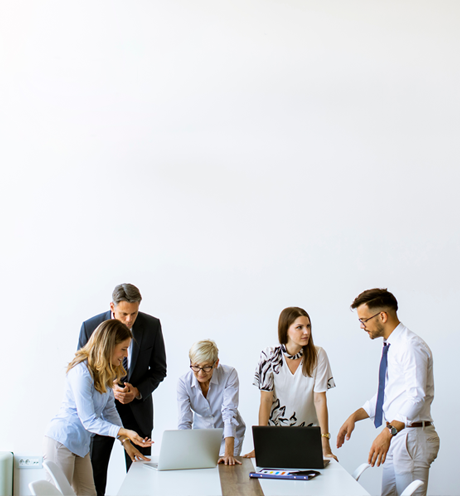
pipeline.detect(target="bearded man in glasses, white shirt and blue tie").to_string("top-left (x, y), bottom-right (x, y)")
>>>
top-left (337, 289), bottom-right (439, 496)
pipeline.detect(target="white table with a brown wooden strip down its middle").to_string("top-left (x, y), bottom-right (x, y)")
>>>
top-left (118, 457), bottom-right (369, 496)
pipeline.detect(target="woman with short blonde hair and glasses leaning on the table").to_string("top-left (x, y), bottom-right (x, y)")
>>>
top-left (177, 339), bottom-right (246, 465)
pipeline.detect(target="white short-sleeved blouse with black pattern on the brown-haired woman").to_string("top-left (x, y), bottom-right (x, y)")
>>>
top-left (253, 346), bottom-right (335, 427)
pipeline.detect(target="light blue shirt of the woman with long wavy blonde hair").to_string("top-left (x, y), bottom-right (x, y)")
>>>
top-left (45, 361), bottom-right (123, 457)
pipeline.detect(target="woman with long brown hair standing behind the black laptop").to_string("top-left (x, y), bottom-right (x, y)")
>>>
top-left (245, 307), bottom-right (337, 459)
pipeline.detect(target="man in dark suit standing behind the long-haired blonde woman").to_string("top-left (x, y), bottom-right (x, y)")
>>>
top-left (78, 284), bottom-right (166, 496)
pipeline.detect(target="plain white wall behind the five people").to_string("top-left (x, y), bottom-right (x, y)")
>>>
top-left (0, 0), bottom-right (460, 496)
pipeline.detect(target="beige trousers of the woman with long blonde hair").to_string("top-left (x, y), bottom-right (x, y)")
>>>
top-left (43, 436), bottom-right (96, 496)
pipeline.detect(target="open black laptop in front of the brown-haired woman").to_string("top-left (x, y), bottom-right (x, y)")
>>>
top-left (252, 425), bottom-right (330, 469)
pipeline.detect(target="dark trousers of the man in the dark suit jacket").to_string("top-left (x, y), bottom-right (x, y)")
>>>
top-left (91, 405), bottom-right (152, 496)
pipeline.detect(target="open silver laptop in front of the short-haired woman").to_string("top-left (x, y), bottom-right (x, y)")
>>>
top-left (144, 429), bottom-right (224, 470)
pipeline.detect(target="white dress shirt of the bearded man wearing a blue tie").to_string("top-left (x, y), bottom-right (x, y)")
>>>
top-left (363, 323), bottom-right (434, 425)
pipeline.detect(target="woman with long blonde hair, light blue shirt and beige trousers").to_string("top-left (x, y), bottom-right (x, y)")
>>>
top-left (43, 319), bottom-right (152, 496)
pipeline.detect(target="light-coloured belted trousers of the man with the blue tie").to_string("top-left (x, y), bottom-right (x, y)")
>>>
top-left (382, 425), bottom-right (439, 496)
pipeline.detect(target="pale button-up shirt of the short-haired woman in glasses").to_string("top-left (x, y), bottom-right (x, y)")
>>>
top-left (177, 364), bottom-right (246, 453)
